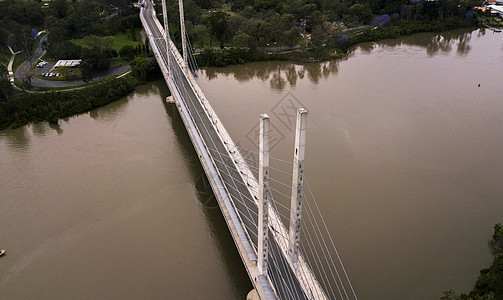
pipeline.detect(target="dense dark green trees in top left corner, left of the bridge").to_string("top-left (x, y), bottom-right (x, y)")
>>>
top-left (0, 0), bottom-right (148, 79)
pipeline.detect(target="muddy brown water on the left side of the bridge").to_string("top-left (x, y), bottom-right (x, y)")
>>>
top-left (0, 81), bottom-right (251, 299)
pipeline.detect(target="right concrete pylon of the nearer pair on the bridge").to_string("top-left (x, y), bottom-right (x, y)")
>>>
top-left (288, 108), bottom-right (307, 267)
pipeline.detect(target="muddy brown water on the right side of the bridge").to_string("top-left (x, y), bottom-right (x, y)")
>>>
top-left (200, 27), bottom-right (503, 299)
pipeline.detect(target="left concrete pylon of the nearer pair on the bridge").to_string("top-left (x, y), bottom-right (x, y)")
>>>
top-left (258, 114), bottom-right (269, 275)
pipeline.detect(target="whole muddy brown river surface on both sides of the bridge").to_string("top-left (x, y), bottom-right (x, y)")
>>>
top-left (0, 30), bottom-right (503, 299)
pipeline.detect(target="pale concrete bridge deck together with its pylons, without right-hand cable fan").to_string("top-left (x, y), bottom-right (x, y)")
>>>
top-left (146, 0), bottom-right (356, 300)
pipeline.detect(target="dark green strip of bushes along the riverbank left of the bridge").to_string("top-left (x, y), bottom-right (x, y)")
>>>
top-left (0, 75), bottom-right (139, 130)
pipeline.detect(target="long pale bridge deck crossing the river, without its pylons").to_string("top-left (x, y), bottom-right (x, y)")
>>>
top-left (140, 1), bottom-right (327, 299)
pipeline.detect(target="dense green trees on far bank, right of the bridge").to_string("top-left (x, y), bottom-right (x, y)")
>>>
top-left (156, 0), bottom-right (483, 52)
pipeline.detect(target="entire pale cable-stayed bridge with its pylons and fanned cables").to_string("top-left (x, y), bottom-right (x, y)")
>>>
top-left (140, 0), bottom-right (357, 299)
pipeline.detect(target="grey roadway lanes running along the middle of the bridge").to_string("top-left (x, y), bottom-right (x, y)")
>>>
top-left (144, 1), bottom-right (305, 299)
